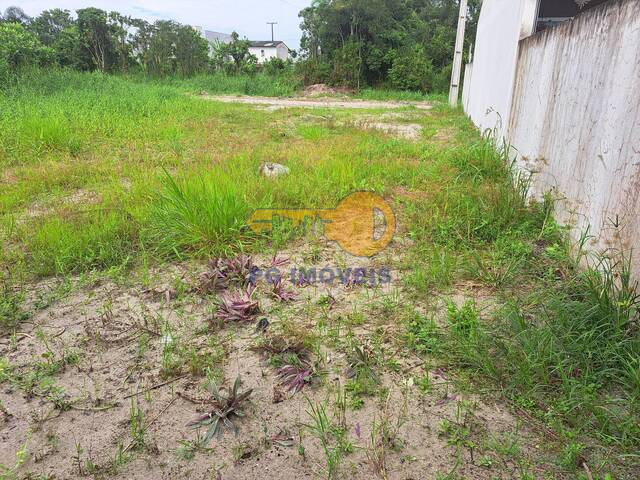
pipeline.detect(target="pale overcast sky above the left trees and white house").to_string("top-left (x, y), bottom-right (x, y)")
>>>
top-left (0, 0), bottom-right (311, 48)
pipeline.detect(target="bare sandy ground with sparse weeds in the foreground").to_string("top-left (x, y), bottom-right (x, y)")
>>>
top-left (0, 241), bottom-right (556, 480)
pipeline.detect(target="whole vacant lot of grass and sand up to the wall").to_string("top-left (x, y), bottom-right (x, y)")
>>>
top-left (0, 73), bottom-right (640, 479)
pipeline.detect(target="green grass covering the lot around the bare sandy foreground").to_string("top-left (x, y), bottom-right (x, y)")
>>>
top-left (0, 71), bottom-right (640, 476)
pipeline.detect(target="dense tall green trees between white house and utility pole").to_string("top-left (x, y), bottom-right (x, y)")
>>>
top-left (300, 0), bottom-right (480, 91)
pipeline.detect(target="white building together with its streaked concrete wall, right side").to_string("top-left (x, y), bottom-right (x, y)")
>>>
top-left (463, 0), bottom-right (640, 280)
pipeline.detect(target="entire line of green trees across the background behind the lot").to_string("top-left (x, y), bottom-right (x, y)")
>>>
top-left (0, 0), bottom-right (480, 91)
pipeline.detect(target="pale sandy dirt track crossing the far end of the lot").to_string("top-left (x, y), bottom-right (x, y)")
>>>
top-left (203, 95), bottom-right (432, 110)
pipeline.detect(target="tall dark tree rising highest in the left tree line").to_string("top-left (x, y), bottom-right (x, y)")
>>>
top-left (76, 7), bottom-right (114, 72)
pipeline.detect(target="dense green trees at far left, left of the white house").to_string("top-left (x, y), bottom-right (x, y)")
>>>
top-left (0, 7), bottom-right (210, 76)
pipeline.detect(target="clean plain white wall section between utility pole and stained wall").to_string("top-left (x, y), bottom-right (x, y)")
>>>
top-left (463, 0), bottom-right (538, 137)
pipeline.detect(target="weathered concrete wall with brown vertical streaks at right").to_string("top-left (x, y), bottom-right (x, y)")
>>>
top-left (510, 0), bottom-right (640, 270)
